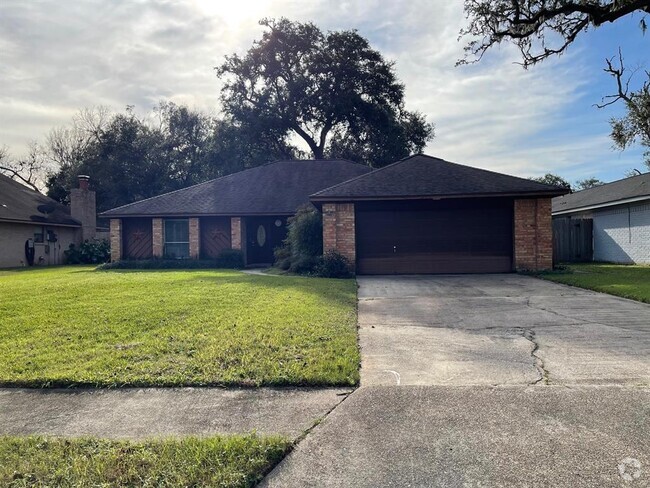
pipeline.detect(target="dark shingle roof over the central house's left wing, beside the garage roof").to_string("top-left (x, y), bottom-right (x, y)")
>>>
top-left (101, 160), bottom-right (372, 217)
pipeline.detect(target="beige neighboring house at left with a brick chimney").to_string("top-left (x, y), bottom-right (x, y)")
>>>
top-left (0, 174), bottom-right (96, 268)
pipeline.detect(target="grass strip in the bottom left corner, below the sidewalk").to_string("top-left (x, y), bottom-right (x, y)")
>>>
top-left (0, 435), bottom-right (290, 487)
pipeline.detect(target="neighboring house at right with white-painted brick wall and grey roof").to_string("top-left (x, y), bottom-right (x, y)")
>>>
top-left (553, 173), bottom-right (650, 264)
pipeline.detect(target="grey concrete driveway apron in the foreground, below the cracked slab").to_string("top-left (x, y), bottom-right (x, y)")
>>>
top-left (261, 386), bottom-right (650, 488)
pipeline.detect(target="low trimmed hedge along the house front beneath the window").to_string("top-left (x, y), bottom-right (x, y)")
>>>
top-left (97, 249), bottom-right (244, 270)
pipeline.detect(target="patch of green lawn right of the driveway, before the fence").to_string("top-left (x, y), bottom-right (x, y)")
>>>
top-left (540, 264), bottom-right (650, 303)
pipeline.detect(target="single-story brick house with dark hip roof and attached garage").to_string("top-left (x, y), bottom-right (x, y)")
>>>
top-left (102, 155), bottom-right (566, 274)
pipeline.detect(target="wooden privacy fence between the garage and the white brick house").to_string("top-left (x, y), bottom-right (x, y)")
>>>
top-left (553, 217), bottom-right (594, 263)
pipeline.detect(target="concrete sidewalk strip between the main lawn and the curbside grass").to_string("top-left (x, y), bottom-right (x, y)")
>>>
top-left (0, 388), bottom-right (351, 439)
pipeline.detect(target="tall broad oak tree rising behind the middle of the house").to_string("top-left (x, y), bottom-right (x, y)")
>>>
top-left (217, 18), bottom-right (433, 166)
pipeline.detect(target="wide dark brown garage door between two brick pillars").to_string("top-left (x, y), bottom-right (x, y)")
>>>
top-left (356, 198), bottom-right (513, 274)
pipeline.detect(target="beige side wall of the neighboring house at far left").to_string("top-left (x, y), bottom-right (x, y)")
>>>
top-left (0, 222), bottom-right (80, 268)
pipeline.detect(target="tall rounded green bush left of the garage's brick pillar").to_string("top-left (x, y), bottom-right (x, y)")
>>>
top-left (275, 205), bottom-right (323, 274)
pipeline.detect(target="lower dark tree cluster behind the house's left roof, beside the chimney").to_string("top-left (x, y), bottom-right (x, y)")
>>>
top-left (42, 103), bottom-right (293, 211)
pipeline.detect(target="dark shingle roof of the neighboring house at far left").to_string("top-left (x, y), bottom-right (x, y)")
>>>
top-left (0, 174), bottom-right (81, 226)
